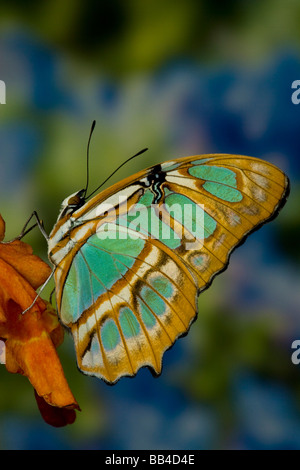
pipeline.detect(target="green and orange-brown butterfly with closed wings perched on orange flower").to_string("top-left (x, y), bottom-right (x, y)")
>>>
top-left (48, 154), bottom-right (289, 383)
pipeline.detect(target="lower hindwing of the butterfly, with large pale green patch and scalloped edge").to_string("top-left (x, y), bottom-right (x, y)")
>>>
top-left (60, 224), bottom-right (197, 382)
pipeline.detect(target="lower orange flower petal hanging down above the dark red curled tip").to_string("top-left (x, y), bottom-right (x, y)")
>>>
top-left (0, 294), bottom-right (79, 409)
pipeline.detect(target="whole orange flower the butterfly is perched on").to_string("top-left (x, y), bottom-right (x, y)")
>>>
top-left (0, 216), bottom-right (80, 426)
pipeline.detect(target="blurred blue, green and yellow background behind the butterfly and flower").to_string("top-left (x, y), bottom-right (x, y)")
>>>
top-left (0, 0), bottom-right (300, 450)
